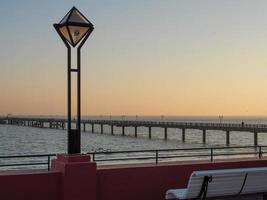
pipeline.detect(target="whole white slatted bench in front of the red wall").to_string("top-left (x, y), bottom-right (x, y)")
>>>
top-left (165, 167), bottom-right (267, 199)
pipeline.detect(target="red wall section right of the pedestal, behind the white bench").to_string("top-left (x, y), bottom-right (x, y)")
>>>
top-left (97, 160), bottom-right (267, 200)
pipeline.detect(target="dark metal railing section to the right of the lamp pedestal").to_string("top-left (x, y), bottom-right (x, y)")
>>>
top-left (88, 146), bottom-right (267, 164)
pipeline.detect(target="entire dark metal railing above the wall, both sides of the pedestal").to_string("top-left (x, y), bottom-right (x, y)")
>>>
top-left (0, 146), bottom-right (267, 171)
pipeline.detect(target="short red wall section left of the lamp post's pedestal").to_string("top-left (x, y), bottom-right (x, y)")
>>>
top-left (0, 171), bottom-right (60, 200)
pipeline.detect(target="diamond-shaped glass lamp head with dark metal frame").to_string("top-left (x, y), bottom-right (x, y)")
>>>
top-left (54, 7), bottom-right (94, 47)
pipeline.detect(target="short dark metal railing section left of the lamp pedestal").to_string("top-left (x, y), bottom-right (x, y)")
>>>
top-left (0, 154), bottom-right (56, 171)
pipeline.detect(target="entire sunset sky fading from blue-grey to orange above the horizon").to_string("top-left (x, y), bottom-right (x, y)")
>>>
top-left (0, 0), bottom-right (267, 116)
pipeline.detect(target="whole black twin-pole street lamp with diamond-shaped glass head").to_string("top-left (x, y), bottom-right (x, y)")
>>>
top-left (54, 7), bottom-right (94, 154)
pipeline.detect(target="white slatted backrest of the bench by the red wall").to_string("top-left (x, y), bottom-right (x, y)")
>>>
top-left (186, 167), bottom-right (267, 198)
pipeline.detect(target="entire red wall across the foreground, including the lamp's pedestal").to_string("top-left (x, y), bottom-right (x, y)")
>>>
top-left (0, 155), bottom-right (267, 200)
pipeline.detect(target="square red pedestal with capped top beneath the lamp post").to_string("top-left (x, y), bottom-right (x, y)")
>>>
top-left (51, 154), bottom-right (97, 200)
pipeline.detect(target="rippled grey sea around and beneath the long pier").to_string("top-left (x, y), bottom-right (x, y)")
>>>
top-left (0, 115), bottom-right (267, 156)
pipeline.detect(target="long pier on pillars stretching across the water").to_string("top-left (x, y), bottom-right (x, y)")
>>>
top-left (0, 117), bottom-right (267, 146)
